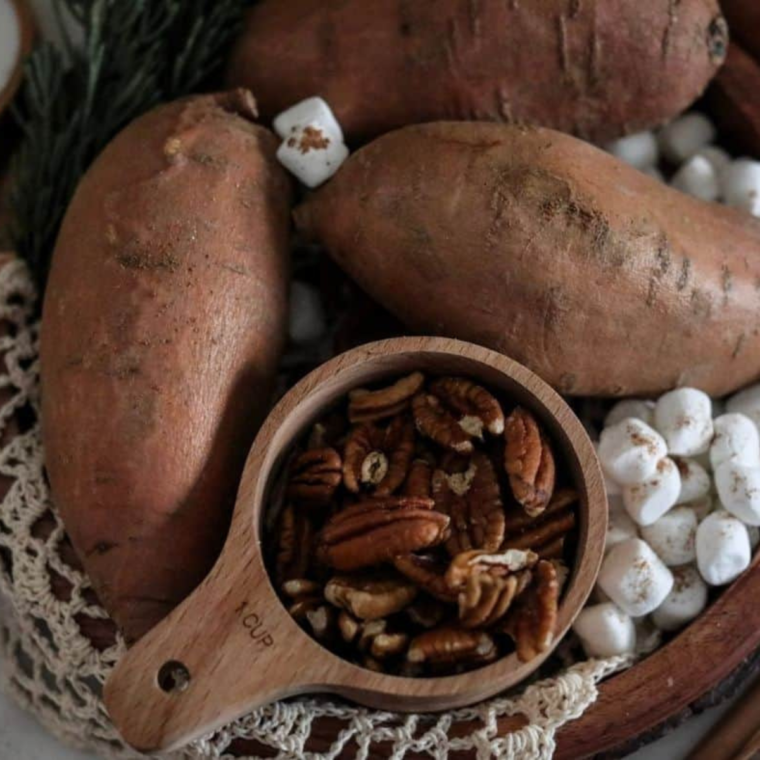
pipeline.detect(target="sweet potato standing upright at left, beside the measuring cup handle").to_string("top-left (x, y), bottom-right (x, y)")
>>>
top-left (41, 91), bottom-right (291, 640)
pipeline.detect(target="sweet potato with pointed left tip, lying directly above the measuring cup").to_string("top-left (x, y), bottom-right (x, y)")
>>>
top-left (296, 122), bottom-right (760, 396)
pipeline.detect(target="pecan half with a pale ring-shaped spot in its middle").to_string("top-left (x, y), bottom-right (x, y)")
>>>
top-left (343, 417), bottom-right (414, 496)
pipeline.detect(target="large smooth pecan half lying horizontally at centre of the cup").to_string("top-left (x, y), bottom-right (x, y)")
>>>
top-left (317, 496), bottom-right (449, 571)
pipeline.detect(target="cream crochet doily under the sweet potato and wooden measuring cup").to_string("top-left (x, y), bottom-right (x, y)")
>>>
top-left (0, 261), bottom-right (629, 760)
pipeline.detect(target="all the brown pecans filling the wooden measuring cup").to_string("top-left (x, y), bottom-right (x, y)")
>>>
top-left (268, 372), bottom-right (578, 676)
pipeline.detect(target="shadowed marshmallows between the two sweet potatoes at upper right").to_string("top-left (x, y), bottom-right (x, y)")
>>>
top-left (605, 112), bottom-right (760, 216)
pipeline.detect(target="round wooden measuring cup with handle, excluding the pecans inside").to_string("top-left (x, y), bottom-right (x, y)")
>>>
top-left (105, 338), bottom-right (607, 751)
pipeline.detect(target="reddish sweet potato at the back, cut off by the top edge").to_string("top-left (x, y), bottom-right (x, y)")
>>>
top-left (228, 0), bottom-right (727, 141)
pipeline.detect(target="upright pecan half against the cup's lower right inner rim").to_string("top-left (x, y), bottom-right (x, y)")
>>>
top-left (504, 560), bottom-right (559, 662)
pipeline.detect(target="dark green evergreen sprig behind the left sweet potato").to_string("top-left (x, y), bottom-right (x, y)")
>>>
top-left (11, 0), bottom-right (250, 287)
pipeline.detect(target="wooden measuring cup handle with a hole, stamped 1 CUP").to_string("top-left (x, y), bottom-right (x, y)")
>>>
top-left (104, 557), bottom-right (321, 752)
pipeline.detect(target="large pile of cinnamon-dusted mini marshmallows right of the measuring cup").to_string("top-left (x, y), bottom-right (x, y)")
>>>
top-left (573, 385), bottom-right (760, 657)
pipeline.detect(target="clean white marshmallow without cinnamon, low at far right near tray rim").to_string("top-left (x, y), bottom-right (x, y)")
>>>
top-left (697, 510), bottom-right (752, 586)
